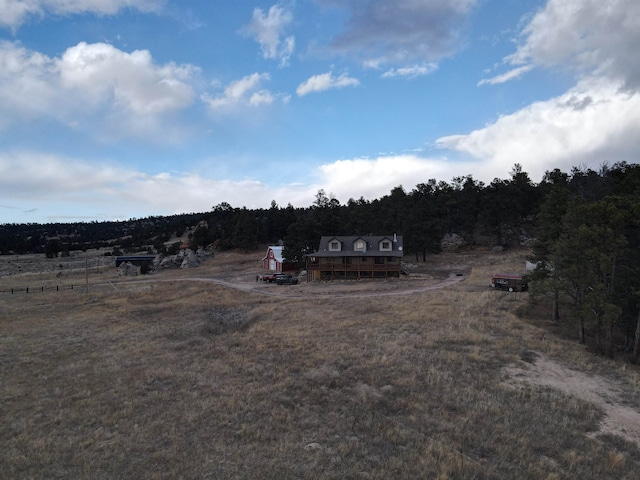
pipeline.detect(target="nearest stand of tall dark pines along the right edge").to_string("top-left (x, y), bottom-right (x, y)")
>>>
top-left (530, 164), bottom-right (640, 363)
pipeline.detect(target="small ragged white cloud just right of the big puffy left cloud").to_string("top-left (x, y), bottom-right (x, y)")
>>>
top-left (201, 73), bottom-right (289, 111)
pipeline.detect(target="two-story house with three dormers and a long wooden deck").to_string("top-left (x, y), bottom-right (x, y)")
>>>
top-left (306, 234), bottom-right (404, 281)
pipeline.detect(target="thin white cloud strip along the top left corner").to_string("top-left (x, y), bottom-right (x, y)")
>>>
top-left (0, 0), bottom-right (165, 29)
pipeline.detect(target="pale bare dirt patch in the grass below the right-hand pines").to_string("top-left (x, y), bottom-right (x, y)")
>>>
top-left (505, 352), bottom-right (640, 447)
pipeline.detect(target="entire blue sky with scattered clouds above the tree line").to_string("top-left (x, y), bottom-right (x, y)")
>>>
top-left (0, 0), bottom-right (640, 223)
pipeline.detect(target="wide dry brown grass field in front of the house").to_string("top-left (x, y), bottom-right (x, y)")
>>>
top-left (0, 252), bottom-right (640, 479)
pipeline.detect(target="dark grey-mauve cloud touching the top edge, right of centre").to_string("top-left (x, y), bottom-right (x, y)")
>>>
top-left (317, 0), bottom-right (477, 65)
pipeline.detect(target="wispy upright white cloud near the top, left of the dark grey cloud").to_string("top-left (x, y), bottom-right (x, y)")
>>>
top-left (243, 5), bottom-right (295, 66)
